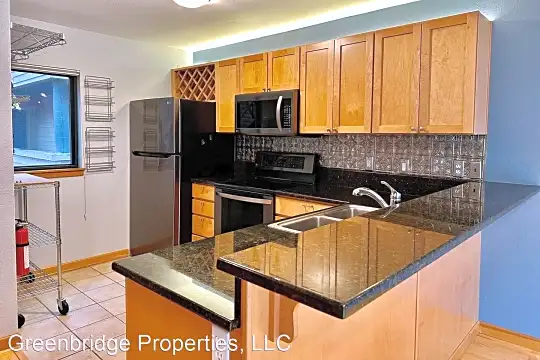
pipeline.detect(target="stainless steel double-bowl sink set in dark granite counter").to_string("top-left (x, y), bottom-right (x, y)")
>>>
top-left (268, 205), bottom-right (379, 234)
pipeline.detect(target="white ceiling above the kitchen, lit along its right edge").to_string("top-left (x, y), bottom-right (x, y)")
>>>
top-left (11, 0), bottom-right (416, 51)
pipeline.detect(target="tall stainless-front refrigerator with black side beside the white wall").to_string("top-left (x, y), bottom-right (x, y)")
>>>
top-left (129, 97), bottom-right (234, 255)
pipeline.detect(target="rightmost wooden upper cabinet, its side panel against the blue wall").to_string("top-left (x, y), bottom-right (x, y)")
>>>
top-left (420, 12), bottom-right (491, 134)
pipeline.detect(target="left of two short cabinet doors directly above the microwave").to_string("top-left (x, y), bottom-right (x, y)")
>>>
top-left (240, 53), bottom-right (268, 94)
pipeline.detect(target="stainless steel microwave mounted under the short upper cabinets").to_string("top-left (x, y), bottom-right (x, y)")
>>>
top-left (235, 89), bottom-right (300, 136)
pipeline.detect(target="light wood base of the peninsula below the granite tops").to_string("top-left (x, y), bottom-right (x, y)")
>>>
top-left (126, 234), bottom-right (481, 360)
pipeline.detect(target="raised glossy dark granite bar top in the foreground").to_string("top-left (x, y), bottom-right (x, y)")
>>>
top-left (218, 182), bottom-right (540, 319)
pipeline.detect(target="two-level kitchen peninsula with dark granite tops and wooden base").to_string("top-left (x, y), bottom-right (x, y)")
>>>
top-left (113, 176), bottom-right (539, 360)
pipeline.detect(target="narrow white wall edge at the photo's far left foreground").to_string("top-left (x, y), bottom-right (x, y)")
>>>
top-left (0, 0), bottom-right (17, 338)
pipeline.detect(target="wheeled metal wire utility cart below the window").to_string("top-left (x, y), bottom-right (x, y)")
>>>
top-left (15, 174), bottom-right (69, 328)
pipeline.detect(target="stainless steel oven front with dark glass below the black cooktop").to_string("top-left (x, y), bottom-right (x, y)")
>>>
top-left (214, 187), bottom-right (274, 235)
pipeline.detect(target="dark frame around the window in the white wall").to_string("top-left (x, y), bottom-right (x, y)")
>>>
top-left (10, 63), bottom-right (80, 172)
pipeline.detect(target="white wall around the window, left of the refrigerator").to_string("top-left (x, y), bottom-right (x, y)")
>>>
top-left (12, 16), bottom-right (192, 266)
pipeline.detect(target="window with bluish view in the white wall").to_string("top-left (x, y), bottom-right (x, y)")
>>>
top-left (11, 67), bottom-right (78, 170)
